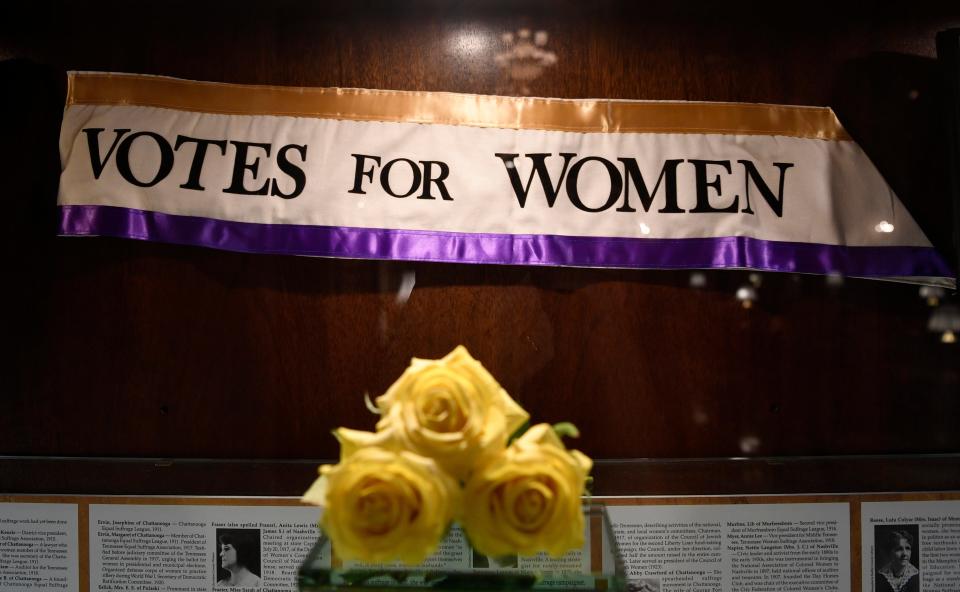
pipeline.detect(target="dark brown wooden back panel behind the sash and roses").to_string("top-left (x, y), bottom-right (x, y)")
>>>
top-left (0, 0), bottom-right (960, 486)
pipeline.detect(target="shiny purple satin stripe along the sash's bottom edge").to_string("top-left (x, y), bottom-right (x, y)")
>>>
top-left (60, 206), bottom-right (953, 277)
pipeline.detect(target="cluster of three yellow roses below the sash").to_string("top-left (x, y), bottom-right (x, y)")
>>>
top-left (303, 346), bottom-right (592, 564)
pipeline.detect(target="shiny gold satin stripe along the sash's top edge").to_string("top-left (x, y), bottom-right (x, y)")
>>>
top-left (67, 72), bottom-right (850, 140)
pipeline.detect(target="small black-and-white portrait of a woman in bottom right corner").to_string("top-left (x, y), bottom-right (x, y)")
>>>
top-left (873, 524), bottom-right (920, 592)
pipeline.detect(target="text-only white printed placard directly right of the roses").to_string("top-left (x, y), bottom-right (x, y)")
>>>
top-left (609, 503), bottom-right (850, 592)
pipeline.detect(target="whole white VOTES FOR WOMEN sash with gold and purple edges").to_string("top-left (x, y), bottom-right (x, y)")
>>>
top-left (58, 72), bottom-right (954, 287)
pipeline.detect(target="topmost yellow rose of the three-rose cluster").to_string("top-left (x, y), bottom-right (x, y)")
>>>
top-left (376, 346), bottom-right (529, 480)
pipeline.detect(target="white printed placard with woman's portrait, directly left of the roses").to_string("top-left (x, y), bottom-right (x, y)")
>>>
top-left (89, 504), bottom-right (320, 592)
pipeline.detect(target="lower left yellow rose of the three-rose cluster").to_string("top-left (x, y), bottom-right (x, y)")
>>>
top-left (303, 444), bottom-right (460, 564)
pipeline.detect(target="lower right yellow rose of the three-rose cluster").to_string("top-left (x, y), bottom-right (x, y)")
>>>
top-left (462, 424), bottom-right (593, 557)
